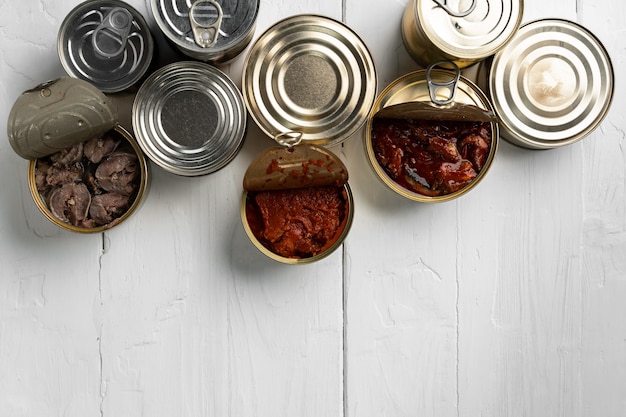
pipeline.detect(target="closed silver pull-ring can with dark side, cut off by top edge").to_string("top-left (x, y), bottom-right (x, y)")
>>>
top-left (150, 0), bottom-right (259, 63)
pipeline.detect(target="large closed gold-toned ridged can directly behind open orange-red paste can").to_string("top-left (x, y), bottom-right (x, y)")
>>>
top-left (242, 15), bottom-right (377, 145)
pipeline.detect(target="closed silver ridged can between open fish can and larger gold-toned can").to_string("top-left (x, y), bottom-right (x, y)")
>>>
top-left (133, 61), bottom-right (246, 176)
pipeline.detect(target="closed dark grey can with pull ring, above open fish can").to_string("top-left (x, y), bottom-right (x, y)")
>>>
top-left (57, 0), bottom-right (154, 93)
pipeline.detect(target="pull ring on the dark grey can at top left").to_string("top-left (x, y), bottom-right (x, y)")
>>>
top-left (91, 7), bottom-right (133, 58)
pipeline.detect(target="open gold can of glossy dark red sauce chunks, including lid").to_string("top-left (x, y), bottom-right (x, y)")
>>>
top-left (364, 63), bottom-right (499, 203)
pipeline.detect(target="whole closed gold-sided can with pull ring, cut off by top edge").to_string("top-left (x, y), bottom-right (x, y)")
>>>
top-left (401, 0), bottom-right (524, 68)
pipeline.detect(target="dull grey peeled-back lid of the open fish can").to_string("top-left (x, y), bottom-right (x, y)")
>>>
top-left (7, 77), bottom-right (117, 159)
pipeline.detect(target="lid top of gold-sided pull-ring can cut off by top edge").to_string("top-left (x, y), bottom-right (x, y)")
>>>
top-left (412, 0), bottom-right (523, 59)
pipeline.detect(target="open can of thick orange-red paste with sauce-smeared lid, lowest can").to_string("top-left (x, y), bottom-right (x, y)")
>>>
top-left (241, 132), bottom-right (354, 264)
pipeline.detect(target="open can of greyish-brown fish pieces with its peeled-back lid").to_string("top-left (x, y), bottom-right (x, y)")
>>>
top-left (8, 78), bottom-right (148, 233)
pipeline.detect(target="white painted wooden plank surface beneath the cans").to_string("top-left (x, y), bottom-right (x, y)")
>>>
top-left (0, 0), bottom-right (626, 417)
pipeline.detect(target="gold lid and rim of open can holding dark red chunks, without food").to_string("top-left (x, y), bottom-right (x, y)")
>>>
top-left (364, 63), bottom-right (499, 203)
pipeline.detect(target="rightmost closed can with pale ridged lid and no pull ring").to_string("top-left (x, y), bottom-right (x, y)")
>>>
top-left (490, 20), bottom-right (614, 148)
